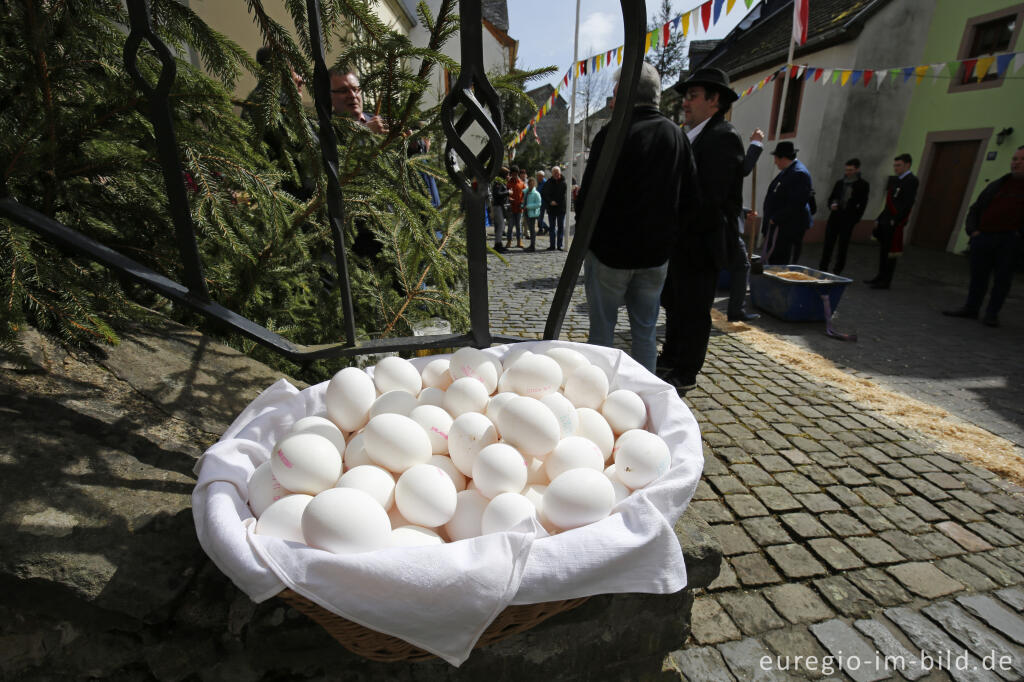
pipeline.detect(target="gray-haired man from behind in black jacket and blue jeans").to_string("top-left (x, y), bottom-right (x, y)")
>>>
top-left (577, 62), bottom-right (697, 372)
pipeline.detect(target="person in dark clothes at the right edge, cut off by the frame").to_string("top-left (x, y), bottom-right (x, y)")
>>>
top-left (942, 146), bottom-right (1024, 327)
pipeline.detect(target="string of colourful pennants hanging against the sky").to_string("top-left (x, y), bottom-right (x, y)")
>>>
top-left (508, 0), bottom-right (754, 148)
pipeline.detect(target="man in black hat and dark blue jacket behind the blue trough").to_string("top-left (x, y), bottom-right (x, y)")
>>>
top-left (761, 141), bottom-right (813, 265)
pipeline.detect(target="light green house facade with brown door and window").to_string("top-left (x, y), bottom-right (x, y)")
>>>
top-left (892, 0), bottom-right (1024, 253)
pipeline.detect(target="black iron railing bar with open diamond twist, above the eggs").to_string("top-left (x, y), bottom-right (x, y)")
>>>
top-left (441, 0), bottom-right (504, 348)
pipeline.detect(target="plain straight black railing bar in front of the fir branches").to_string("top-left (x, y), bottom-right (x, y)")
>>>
top-left (306, 0), bottom-right (355, 345)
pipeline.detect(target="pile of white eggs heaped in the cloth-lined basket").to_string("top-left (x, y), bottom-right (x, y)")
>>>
top-left (249, 347), bottom-right (671, 554)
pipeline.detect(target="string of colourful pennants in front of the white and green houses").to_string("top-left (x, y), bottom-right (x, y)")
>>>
top-left (739, 52), bottom-right (1024, 100)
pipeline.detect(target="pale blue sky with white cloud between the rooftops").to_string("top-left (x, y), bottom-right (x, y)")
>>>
top-left (508, 0), bottom-right (748, 93)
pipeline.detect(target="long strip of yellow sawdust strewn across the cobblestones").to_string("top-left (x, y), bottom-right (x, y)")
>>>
top-left (712, 310), bottom-right (1024, 485)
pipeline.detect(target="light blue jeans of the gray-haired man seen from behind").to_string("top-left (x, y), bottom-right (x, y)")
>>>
top-left (584, 251), bottom-right (669, 373)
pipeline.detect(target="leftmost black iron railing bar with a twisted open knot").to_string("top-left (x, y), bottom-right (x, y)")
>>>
top-left (125, 0), bottom-right (210, 300)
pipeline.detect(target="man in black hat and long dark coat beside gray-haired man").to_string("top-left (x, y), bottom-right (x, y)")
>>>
top-left (659, 69), bottom-right (743, 390)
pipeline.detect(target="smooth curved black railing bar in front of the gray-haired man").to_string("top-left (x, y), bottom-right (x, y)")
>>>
top-left (544, 0), bottom-right (647, 339)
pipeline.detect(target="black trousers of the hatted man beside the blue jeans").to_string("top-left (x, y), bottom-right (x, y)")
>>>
top-left (662, 257), bottom-right (718, 379)
